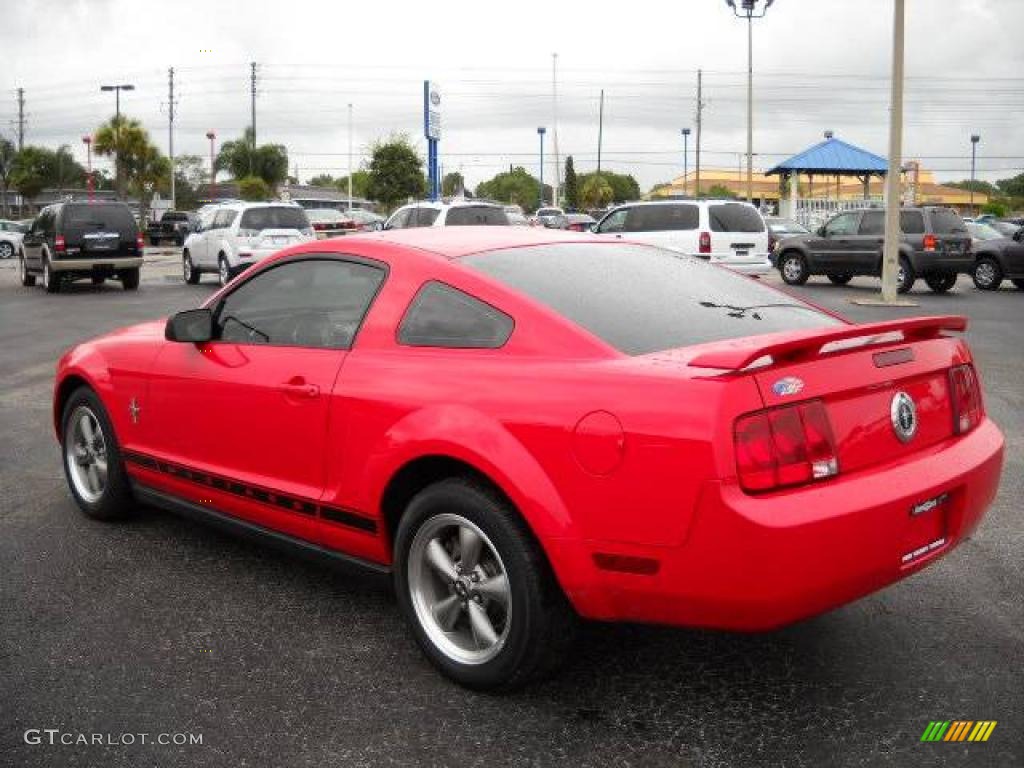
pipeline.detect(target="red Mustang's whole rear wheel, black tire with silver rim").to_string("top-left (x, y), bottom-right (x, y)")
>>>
top-left (394, 478), bottom-right (577, 690)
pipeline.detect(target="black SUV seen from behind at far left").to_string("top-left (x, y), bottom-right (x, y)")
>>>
top-left (18, 202), bottom-right (143, 293)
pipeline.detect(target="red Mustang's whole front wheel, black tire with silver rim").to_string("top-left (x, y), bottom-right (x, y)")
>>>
top-left (60, 386), bottom-right (135, 520)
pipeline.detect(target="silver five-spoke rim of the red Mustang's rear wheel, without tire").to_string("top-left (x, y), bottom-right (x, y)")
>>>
top-left (407, 513), bottom-right (512, 665)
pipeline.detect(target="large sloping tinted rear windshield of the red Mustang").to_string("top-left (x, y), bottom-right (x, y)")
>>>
top-left (462, 243), bottom-right (840, 354)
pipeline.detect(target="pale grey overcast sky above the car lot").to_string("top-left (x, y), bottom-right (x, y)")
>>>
top-left (0, 0), bottom-right (1024, 189)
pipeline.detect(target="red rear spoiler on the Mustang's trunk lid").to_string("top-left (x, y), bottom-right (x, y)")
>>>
top-left (686, 314), bottom-right (967, 371)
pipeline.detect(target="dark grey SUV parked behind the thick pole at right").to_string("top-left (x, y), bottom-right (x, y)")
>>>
top-left (774, 206), bottom-right (974, 293)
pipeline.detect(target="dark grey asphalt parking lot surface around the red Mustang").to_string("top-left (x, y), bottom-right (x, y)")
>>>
top-left (0, 251), bottom-right (1024, 768)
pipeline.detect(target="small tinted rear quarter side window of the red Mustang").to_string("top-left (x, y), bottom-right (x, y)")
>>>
top-left (398, 282), bottom-right (514, 349)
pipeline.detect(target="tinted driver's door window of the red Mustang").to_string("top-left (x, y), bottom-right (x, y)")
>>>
top-left (216, 259), bottom-right (385, 349)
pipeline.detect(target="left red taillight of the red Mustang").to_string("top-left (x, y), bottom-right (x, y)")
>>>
top-left (734, 400), bottom-right (839, 490)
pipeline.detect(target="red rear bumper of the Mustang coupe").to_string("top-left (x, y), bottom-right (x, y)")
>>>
top-left (566, 420), bottom-right (1002, 631)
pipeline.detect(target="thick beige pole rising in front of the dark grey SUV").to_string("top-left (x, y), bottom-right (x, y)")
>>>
top-left (882, 0), bottom-right (904, 303)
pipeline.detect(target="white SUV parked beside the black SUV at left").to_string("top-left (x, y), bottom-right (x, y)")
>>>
top-left (181, 203), bottom-right (315, 286)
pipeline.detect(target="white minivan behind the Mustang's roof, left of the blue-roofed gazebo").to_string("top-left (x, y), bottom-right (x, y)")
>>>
top-left (594, 200), bottom-right (771, 274)
